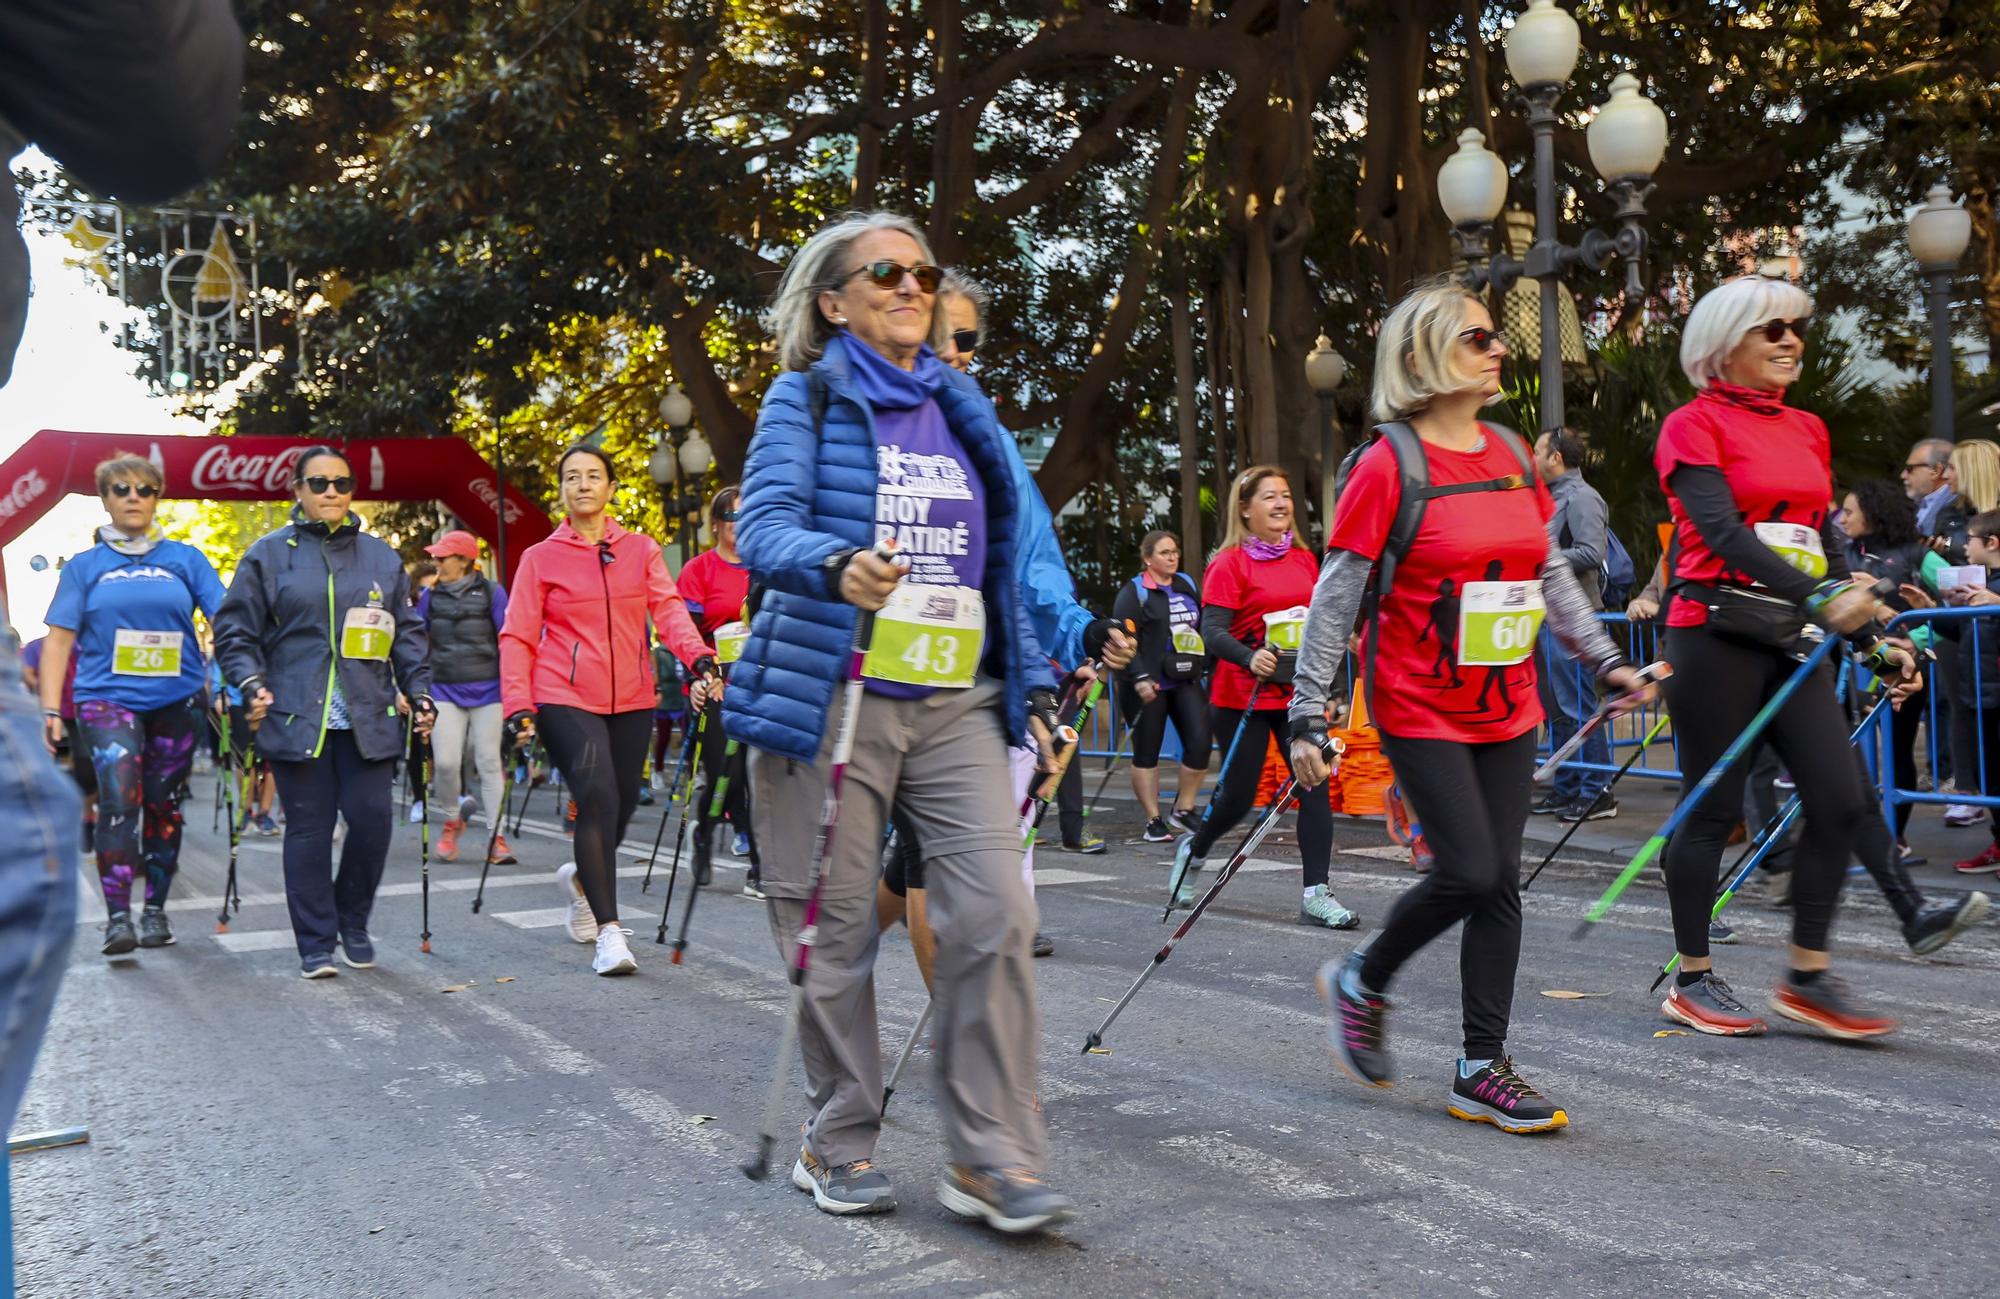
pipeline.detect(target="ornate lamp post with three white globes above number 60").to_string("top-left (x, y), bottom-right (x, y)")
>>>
top-left (1438, 0), bottom-right (1666, 430)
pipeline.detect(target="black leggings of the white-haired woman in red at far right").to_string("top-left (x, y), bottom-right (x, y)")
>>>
top-left (1664, 628), bottom-right (1894, 957)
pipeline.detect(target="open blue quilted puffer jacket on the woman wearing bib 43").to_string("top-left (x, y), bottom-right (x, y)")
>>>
top-left (722, 329), bottom-right (1056, 761)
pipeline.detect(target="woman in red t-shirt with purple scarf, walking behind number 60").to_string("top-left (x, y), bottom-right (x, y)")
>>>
top-left (1170, 464), bottom-right (1362, 929)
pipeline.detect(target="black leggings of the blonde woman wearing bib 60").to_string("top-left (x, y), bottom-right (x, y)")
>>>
top-left (1360, 729), bottom-right (1534, 1059)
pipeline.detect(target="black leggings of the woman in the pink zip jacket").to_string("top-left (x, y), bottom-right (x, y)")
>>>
top-left (536, 703), bottom-right (652, 925)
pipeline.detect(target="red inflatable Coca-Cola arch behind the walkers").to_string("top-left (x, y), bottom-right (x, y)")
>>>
top-left (0, 428), bottom-right (554, 594)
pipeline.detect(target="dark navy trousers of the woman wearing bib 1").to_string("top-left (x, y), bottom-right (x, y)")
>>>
top-left (270, 731), bottom-right (396, 957)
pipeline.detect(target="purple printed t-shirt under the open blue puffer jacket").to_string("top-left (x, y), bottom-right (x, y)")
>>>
top-left (866, 402), bottom-right (986, 699)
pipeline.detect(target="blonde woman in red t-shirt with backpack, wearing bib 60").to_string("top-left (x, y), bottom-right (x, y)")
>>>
top-left (1290, 282), bottom-right (1648, 1131)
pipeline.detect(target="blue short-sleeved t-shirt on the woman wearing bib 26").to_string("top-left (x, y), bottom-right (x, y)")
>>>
top-left (46, 542), bottom-right (226, 713)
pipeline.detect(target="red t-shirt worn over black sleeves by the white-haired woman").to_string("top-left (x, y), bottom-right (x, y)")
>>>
top-left (1652, 388), bottom-right (1834, 628)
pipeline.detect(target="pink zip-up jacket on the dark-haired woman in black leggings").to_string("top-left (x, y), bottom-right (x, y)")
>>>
top-left (500, 520), bottom-right (708, 717)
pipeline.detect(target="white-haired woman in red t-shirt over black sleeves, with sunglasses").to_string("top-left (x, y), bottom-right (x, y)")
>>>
top-left (1654, 276), bottom-right (1922, 1037)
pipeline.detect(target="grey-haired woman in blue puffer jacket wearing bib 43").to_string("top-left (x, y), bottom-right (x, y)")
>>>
top-left (724, 212), bottom-right (1072, 1231)
